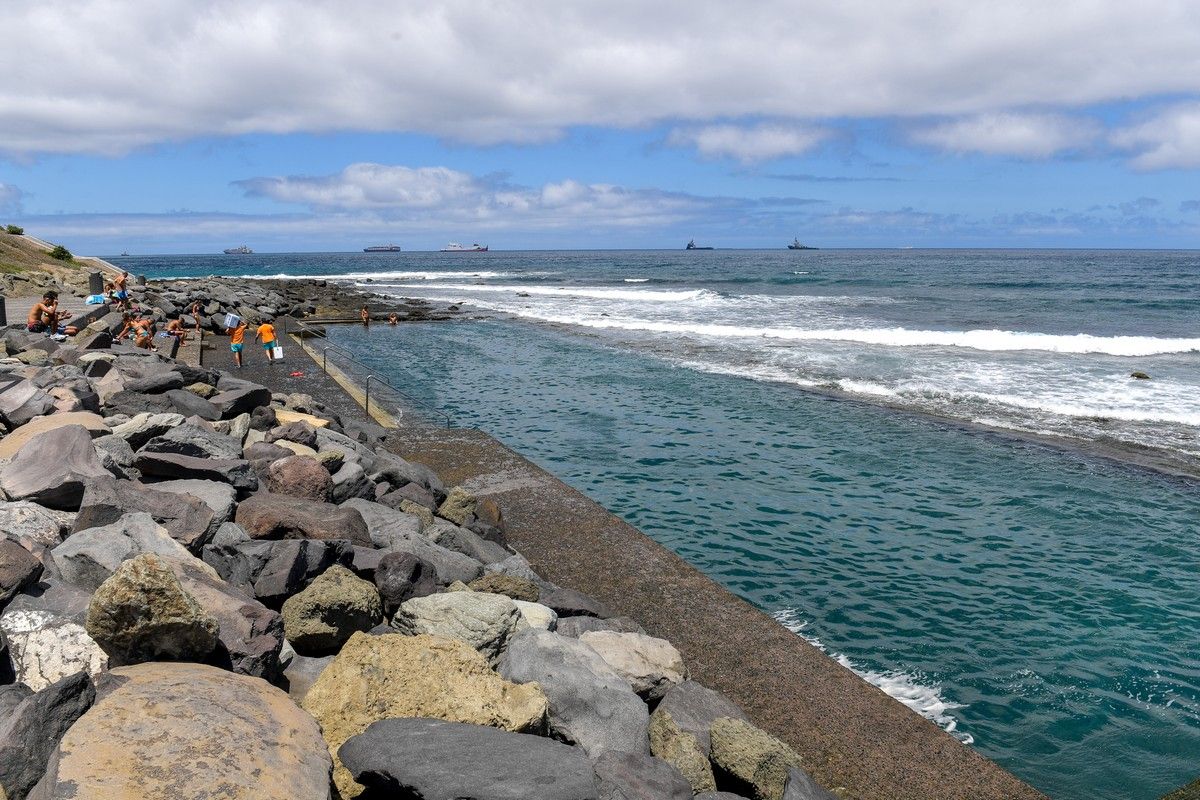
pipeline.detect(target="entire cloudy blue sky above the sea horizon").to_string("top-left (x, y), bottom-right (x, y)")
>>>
top-left (0, 0), bottom-right (1200, 254)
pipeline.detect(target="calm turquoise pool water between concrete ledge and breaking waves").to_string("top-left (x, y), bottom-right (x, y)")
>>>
top-left (335, 321), bottom-right (1200, 800)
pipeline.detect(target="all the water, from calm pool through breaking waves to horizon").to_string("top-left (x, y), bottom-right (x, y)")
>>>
top-left (131, 249), bottom-right (1200, 800)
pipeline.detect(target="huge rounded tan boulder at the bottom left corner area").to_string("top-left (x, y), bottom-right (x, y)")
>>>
top-left (38, 662), bottom-right (330, 800)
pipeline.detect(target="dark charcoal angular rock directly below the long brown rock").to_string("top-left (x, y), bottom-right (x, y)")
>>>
top-left (202, 539), bottom-right (350, 608)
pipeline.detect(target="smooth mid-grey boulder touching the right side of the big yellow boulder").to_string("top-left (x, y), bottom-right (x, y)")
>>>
top-left (497, 628), bottom-right (649, 758)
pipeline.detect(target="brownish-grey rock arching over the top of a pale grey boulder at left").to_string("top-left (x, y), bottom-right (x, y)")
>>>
top-left (72, 479), bottom-right (215, 552)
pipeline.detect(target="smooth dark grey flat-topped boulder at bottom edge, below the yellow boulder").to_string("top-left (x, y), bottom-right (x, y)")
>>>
top-left (337, 718), bottom-right (599, 800)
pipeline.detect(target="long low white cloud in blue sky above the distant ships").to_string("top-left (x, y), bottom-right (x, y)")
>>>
top-left (238, 163), bottom-right (720, 228)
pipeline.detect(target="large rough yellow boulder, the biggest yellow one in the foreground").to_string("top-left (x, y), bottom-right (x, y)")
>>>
top-left (304, 633), bottom-right (546, 798)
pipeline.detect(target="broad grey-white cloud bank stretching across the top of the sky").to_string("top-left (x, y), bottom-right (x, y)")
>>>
top-left (0, 0), bottom-right (1200, 155)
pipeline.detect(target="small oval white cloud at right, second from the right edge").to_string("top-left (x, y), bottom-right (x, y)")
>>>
top-left (910, 113), bottom-right (1100, 158)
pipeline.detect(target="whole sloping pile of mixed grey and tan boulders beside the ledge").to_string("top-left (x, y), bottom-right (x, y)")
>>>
top-left (0, 321), bottom-right (833, 800)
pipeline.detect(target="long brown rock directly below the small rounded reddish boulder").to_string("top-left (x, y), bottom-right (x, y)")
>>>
top-left (234, 493), bottom-right (371, 547)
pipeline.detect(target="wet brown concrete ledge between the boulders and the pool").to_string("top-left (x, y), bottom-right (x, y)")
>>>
top-left (258, 335), bottom-right (1044, 800)
